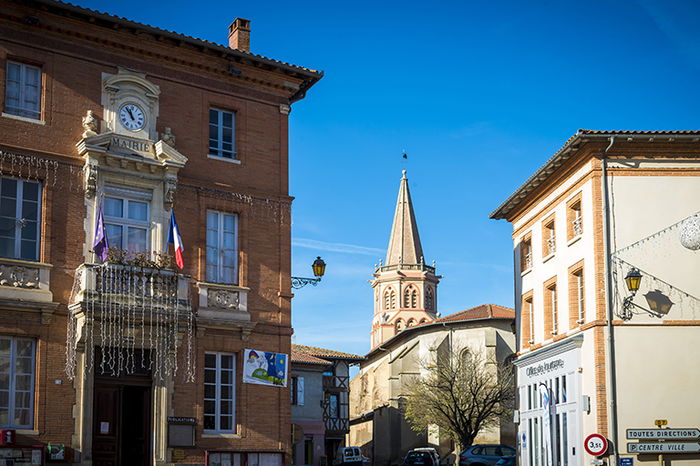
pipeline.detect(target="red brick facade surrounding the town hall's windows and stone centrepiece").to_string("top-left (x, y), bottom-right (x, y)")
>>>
top-left (0, 0), bottom-right (322, 464)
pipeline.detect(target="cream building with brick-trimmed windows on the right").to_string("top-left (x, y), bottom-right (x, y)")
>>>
top-left (491, 130), bottom-right (700, 466)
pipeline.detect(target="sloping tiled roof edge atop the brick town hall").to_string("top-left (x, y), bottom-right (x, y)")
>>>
top-left (27, 0), bottom-right (323, 78)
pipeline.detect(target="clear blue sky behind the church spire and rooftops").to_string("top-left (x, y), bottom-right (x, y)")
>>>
top-left (78, 0), bottom-right (700, 354)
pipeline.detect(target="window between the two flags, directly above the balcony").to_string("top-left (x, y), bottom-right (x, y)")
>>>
top-left (104, 187), bottom-right (151, 252)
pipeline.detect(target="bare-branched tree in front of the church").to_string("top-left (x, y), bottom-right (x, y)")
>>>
top-left (405, 350), bottom-right (515, 448)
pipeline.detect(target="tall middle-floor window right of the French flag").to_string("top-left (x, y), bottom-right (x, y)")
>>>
top-left (207, 210), bottom-right (238, 285)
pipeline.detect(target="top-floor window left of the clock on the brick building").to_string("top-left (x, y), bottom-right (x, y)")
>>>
top-left (5, 61), bottom-right (41, 120)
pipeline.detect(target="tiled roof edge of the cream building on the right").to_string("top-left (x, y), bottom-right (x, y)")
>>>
top-left (489, 129), bottom-right (700, 220)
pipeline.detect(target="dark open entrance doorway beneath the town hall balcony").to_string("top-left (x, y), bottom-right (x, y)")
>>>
top-left (92, 348), bottom-right (152, 466)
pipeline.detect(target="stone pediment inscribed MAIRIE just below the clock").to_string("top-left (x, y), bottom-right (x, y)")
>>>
top-left (77, 132), bottom-right (187, 168)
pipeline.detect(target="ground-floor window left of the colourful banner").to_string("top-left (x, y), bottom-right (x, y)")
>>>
top-left (204, 353), bottom-right (236, 433)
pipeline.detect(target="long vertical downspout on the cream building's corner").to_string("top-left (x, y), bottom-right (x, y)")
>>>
top-left (601, 136), bottom-right (619, 465)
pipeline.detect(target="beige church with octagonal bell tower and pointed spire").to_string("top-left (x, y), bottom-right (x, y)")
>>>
top-left (347, 171), bottom-right (515, 466)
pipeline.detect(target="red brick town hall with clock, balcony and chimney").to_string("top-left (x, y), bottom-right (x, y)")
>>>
top-left (0, 0), bottom-right (322, 466)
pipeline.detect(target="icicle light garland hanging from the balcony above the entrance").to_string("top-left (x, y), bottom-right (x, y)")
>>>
top-left (65, 262), bottom-right (195, 382)
